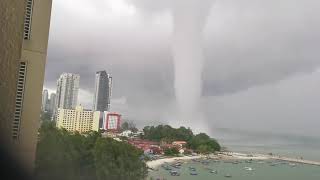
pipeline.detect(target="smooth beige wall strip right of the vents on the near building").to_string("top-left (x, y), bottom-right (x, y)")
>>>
top-left (16, 0), bottom-right (52, 172)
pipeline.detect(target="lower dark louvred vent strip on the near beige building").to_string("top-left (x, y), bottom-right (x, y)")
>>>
top-left (12, 62), bottom-right (27, 139)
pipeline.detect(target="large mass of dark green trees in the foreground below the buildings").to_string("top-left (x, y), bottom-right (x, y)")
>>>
top-left (36, 121), bottom-right (147, 180)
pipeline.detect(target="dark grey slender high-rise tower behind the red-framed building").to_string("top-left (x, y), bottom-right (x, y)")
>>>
top-left (93, 71), bottom-right (112, 111)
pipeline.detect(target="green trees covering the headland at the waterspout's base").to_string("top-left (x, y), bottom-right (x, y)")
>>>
top-left (143, 125), bottom-right (221, 154)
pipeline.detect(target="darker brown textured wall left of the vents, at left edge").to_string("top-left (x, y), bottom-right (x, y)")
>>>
top-left (0, 0), bottom-right (25, 148)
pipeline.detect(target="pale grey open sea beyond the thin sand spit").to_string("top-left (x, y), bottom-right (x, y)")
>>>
top-left (212, 129), bottom-right (320, 161)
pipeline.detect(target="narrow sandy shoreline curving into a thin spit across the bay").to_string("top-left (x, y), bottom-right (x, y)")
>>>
top-left (146, 152), bottom-right (320, 169)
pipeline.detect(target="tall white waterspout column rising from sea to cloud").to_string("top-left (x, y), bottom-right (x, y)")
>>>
top-left (172, 0), bottom-right (213, 130)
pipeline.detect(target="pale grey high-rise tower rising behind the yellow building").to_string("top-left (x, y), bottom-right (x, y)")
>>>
top-left (55, 73), bottom-right (80, 110)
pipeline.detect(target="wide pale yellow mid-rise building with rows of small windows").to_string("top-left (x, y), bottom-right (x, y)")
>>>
top-left (57, 106), bottom-right (94, 133)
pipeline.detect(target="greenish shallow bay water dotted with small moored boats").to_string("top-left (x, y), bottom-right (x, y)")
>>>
top-left (148, 161), bottom-right (320, 180)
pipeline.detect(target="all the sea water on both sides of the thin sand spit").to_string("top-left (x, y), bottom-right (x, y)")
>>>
top-left (148, 129), bottom-right (320, 180)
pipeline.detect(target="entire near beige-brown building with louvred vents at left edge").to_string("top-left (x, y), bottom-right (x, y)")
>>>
top-left (0, 0), bottom-right (52, 173)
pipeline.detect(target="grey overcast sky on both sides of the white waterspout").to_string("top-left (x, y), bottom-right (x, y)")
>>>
top-left (44, 0), bottom-right (320, 137)
